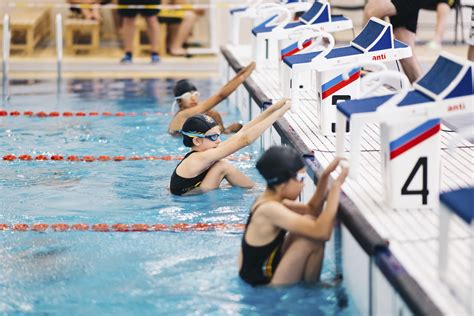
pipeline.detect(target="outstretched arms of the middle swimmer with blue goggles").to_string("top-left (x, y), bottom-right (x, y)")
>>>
top-left (195, 99), bottom-right (291, 163)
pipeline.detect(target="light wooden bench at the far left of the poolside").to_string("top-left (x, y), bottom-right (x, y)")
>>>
top-left (0, 9), bottom-right (51, 56)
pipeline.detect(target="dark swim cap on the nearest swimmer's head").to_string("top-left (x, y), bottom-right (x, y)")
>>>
top-left (257, 146), bottom-right (304, 185)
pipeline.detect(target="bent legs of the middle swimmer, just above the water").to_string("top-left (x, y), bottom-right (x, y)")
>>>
top-left (199, 160), bottom-right (255, 190)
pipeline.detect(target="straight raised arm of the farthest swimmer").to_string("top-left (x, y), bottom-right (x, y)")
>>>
top-left (190, 62), bottom-right (255, 115)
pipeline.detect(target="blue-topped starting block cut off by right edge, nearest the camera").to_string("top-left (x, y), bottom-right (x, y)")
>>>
top-left (438, 187), bottom-right (474, 314)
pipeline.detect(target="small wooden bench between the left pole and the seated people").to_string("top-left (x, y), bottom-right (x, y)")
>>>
top-left (64, 18), bottom-right (100, 54)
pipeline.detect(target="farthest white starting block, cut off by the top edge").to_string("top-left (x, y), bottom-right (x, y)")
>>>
top-left (229, 0), bottom-right (311, 45)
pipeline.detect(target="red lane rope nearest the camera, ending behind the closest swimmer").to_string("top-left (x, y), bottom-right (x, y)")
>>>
top-left (0, 223), bottom-right (245, 232)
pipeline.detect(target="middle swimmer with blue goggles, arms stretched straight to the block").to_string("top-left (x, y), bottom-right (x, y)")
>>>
top-left (170, 99), bottom-right (291, 195)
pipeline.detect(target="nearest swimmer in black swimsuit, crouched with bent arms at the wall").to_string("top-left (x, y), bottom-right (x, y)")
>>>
top-left (239, 146), bottom-right (348, 286)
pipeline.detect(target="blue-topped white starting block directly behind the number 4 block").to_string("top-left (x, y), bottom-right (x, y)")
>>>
top-left (283, 18), bottom-right (412, 121)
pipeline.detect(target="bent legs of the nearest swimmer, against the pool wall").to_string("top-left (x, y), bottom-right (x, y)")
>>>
top-left (271, 234), bottom-right (324, 285)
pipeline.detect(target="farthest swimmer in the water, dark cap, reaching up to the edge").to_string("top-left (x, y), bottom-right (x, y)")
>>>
top-left (168, 62), bottom-right (255, 135)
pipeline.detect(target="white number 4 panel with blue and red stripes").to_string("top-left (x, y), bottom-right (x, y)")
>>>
top-left (380, 119), bottom-right (441, 208)
